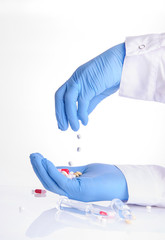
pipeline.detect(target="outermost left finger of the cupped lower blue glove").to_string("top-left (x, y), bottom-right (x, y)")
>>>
top-left (30, 153), bottom-right (66, 196)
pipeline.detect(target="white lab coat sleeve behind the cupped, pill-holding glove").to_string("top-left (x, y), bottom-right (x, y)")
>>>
top-left (117, 165), bottom-right (165, 207)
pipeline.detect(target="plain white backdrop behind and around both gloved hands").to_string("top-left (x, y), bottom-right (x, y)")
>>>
top-left (0, 0), bottom-right (165, 186)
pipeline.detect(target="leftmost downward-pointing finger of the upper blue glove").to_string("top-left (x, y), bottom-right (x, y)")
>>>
top-left (55, 84), bottom-right (68, 131)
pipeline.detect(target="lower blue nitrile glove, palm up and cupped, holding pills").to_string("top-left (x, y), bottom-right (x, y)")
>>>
top-left (30, 153), bottom-right (128, 202)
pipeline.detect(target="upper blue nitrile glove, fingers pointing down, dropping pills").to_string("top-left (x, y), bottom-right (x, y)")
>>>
top-left (55, 43), bottom-right (125, 131)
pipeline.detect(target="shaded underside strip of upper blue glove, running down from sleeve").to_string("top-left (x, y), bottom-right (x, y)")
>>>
top-left (88, 85), bottom-right (119, 114)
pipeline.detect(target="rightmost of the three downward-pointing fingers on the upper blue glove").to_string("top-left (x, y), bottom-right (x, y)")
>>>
top-left (78, 98), bottom-right (89, 126)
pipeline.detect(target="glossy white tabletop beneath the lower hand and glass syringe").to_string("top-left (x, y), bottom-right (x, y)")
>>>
top-left (0, 186), bottom-right (165, 240)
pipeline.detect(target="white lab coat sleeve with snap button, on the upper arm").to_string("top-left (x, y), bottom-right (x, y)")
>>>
top-left (119, 33), bottom-right (165, 103)
